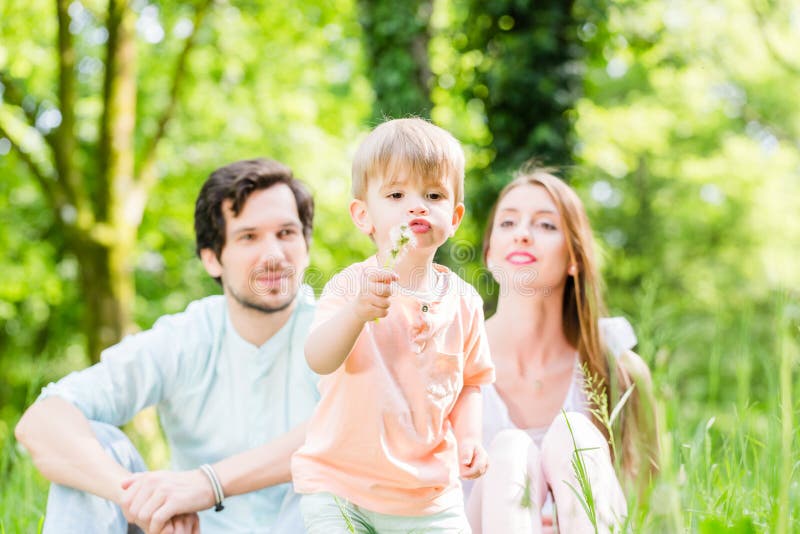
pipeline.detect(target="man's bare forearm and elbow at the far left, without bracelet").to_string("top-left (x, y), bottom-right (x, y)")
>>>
top-left (15, 397), bottom-right (130, 503)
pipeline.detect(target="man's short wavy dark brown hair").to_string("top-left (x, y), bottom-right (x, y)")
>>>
top-left (194, 158), bottom-right (314, 258)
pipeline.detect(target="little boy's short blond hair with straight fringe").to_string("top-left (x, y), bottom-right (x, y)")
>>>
top-left (352, 117), bottom-right (464, 203)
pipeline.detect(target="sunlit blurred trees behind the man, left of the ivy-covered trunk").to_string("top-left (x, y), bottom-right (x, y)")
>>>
top-left (0, 1), bottom-right (369, 414)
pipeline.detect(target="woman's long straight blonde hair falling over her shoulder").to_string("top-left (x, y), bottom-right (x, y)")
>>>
top-left (483, 164), bottom-right (649, 481)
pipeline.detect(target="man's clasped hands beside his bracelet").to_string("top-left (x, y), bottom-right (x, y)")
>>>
top-left (120, 469), bottom-right (214, 533)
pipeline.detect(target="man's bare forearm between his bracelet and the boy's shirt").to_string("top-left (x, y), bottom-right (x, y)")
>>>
top-left (213, 423), bottom-right (307, 496)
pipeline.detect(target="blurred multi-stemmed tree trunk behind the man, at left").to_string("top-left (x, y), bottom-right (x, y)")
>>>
top-left (0, 0), bottom-right (220, 361)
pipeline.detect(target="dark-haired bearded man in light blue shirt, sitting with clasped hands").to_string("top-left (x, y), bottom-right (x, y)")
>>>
top-left (16, 159), bottom-right (318, 533)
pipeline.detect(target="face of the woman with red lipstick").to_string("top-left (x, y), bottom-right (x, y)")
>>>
top-left (486, 184), bottom-right (569, 296)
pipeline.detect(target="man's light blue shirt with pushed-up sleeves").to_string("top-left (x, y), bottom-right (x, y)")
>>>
top-left (40, 286), bottom-right (319, 533)
